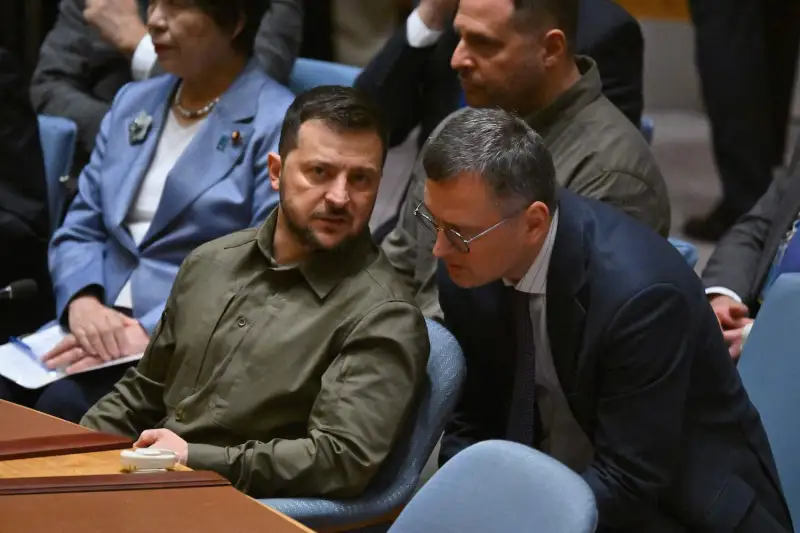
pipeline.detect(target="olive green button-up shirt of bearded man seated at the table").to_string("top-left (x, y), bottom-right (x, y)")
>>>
top-left (81, 210), bottom-right (429, 497)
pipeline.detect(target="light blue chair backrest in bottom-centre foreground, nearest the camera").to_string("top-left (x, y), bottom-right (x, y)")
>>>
top-left (389, 441), bottom-right (597, 533)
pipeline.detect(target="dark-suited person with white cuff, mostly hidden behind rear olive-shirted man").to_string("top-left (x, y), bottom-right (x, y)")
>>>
top-left (356, 0), bottom-right (644, 146)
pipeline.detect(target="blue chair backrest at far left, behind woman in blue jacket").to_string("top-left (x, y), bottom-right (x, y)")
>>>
top-left (38, 115), bottom-right (78, 233)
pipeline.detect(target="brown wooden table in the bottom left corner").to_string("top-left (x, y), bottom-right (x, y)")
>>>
top-left (0, 400), bottom-right (314, 533)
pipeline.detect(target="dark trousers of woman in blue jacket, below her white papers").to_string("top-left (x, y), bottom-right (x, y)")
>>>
top-left (0, 363), bottom-right (136, 424)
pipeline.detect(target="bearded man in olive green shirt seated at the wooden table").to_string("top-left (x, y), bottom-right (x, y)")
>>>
top-left (81, 87), bottom-right (429, 497)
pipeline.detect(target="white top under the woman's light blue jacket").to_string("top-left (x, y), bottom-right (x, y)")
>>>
top-left (114, 111), bottom-right (205, 309)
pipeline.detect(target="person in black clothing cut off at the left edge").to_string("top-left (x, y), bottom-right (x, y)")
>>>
top-left (0, 49), bottom-right (54, 344)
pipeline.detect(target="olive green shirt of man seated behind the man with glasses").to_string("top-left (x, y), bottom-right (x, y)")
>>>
top-left (381, 56), bottom-right (671, 319)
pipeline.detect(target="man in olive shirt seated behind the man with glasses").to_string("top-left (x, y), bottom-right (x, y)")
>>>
top-left (382, 0), bottom-right (670, 319)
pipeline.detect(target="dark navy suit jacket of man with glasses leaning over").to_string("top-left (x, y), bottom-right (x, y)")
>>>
top-left (439, 191), bottom-right (790, 533)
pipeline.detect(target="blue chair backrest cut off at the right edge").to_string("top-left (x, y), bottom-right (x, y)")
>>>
top-left (738, 274), bottom-right (800, 524)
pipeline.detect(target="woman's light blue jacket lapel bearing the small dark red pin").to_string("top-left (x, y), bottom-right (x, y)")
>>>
top-left (142, 61), bottom-right (264, 246)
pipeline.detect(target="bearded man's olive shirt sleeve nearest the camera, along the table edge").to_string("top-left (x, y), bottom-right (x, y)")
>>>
top-left (188, 302), bottom-right (430, 498)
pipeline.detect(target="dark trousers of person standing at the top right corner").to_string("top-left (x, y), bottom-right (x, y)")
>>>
top-left (689, 0), bottom-right (800, 213)
